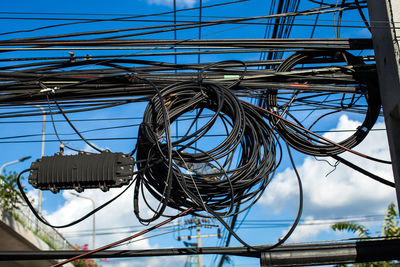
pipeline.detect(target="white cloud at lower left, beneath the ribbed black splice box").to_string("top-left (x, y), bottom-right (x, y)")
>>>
top-left (46, 181), bottom-right (186, 267)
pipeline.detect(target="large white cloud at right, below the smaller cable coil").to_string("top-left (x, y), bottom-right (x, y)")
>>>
top-left (260, 116), bottom-right (396, 241)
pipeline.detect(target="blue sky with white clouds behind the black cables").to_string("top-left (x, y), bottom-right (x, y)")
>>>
top-left (0, 0), bottom-right (395, 267)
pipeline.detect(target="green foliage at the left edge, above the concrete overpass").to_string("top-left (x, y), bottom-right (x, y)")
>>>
top-left (0, 172), bottom-right (22, 213)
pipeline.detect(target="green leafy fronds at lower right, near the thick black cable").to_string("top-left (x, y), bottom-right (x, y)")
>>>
top-left (331, 202), bottom-right (400, 267)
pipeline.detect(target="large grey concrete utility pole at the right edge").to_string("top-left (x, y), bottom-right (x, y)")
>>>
top-left (367, 0), bottom-right (400, 209)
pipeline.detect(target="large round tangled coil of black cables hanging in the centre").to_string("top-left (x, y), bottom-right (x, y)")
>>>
top-left (134, 79), bottom-right (277, 222)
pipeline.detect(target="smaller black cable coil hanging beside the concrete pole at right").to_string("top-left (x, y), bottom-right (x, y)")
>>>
top-left (267, 50), bottom-right (381, 156)
